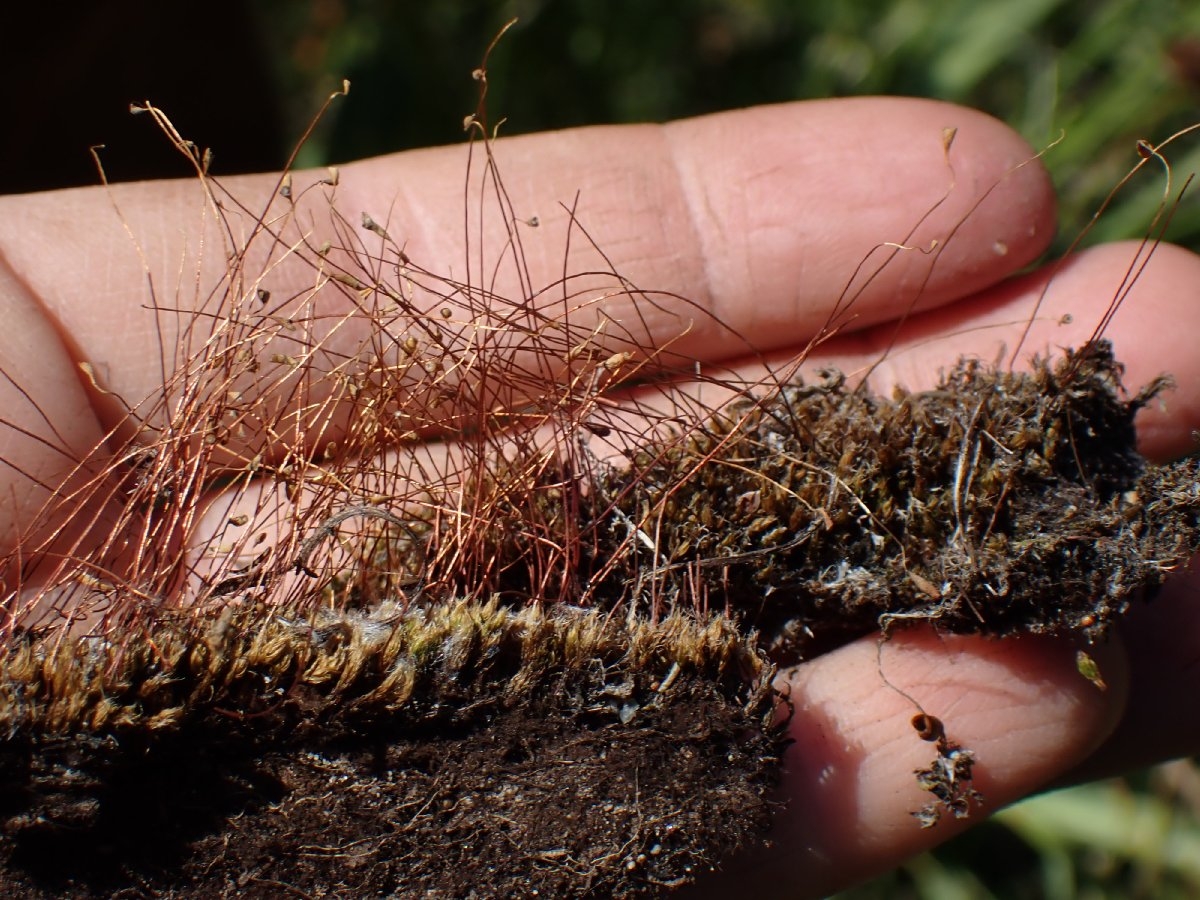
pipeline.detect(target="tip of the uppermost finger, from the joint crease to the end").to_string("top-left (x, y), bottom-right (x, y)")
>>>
top-left (666, 97), bottom-right (1056, 340)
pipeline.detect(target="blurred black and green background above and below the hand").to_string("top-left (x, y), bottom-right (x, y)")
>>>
top-left (9, 0), bottom-right (1200, 900)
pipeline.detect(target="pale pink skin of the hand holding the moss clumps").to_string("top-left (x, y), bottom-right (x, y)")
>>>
top-left (0, 100), bottom-right (1200, 896)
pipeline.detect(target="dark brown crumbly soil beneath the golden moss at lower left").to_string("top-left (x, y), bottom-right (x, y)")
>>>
top-left (0, 607), bottom-right (782, 898)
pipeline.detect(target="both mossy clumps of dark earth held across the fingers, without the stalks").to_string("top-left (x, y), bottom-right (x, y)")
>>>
top-left (0, 342), bottom-right (1200, 898)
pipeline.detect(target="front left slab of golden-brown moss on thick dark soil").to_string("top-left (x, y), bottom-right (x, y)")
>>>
top-left (0, 602), bottom-right (782, 898)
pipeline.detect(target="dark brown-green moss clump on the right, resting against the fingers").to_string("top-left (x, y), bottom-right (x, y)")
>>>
top-left (576, 341), bottom-right (1200, 655)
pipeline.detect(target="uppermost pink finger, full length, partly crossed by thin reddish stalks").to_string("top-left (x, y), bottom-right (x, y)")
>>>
top-left (0, 100), bottom-right (1052, 460)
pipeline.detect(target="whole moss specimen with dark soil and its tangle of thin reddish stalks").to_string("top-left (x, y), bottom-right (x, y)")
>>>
top-left (0, 81), bottom-right (1200, 896)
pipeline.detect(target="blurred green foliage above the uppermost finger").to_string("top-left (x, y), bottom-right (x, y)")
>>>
top-left (256, 0), bottom-right (1200, 248)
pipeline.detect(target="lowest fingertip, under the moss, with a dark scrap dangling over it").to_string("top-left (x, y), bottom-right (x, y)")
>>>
top-left (686, 629), bottom-right (1124, 896)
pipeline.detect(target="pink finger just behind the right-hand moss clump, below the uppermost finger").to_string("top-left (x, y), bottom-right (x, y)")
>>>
top-left (810, 241), bottom-right (1200, 460)
